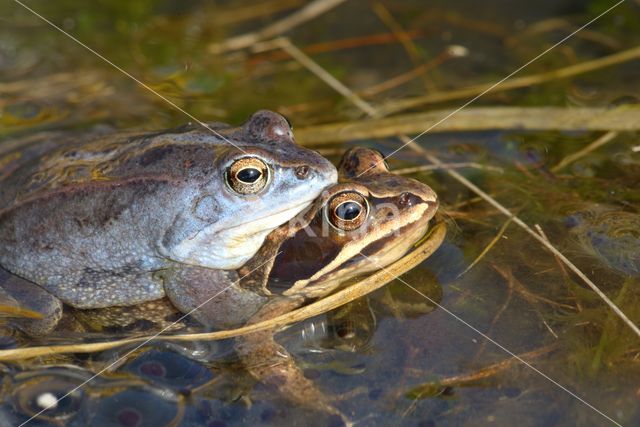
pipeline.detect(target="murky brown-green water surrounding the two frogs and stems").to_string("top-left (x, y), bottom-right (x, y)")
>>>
top-left (0, 0), bottom-right (640, 426)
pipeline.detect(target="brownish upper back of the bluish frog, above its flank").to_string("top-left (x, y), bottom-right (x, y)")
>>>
top-left (0, 125), bottom-right (222, 207)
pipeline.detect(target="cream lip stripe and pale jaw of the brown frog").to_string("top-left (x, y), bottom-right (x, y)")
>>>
top-left (283, 204), bottom-right (435, 295)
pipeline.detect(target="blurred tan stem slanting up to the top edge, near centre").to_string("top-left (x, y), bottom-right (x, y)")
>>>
top-left (208, 0), bottom-right (345, 54)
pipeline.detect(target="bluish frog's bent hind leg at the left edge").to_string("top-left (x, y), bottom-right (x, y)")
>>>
top-left (0, 268), bottom-right (62, 337)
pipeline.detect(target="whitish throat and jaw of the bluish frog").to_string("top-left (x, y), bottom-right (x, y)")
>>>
top-left (172, 199), bottom-right (314, 270)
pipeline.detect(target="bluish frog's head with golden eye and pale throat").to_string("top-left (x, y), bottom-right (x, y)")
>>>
top-left (165, 111), bottom-right (337, 269)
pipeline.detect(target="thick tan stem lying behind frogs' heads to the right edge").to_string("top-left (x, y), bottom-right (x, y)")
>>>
top-left (296, 107), bottom-right (640, 146)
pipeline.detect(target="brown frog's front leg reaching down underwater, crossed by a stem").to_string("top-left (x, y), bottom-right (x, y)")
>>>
top-left (235, 298), bottom-right (353, 425)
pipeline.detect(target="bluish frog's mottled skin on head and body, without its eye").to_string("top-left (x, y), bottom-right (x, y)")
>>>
top-left (0, 111), bottom-right (336, 336)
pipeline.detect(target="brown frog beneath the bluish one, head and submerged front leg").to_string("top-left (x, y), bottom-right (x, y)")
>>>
top-left (236, 148), bottom-right (438, 421)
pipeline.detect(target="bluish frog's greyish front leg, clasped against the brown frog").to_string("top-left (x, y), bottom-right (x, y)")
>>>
top-left (164, 265), bottom-right (266, 329)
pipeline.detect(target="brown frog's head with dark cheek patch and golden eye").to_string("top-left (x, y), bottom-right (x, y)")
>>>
top-left (260, 148), bottom-right (438, 297)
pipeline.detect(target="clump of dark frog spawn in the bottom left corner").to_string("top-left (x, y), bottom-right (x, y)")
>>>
top-left (0, 349), bottom-right (214, 427)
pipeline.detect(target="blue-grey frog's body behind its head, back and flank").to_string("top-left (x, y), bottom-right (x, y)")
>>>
top-left (0, 125), bottom-right (231, 307)
